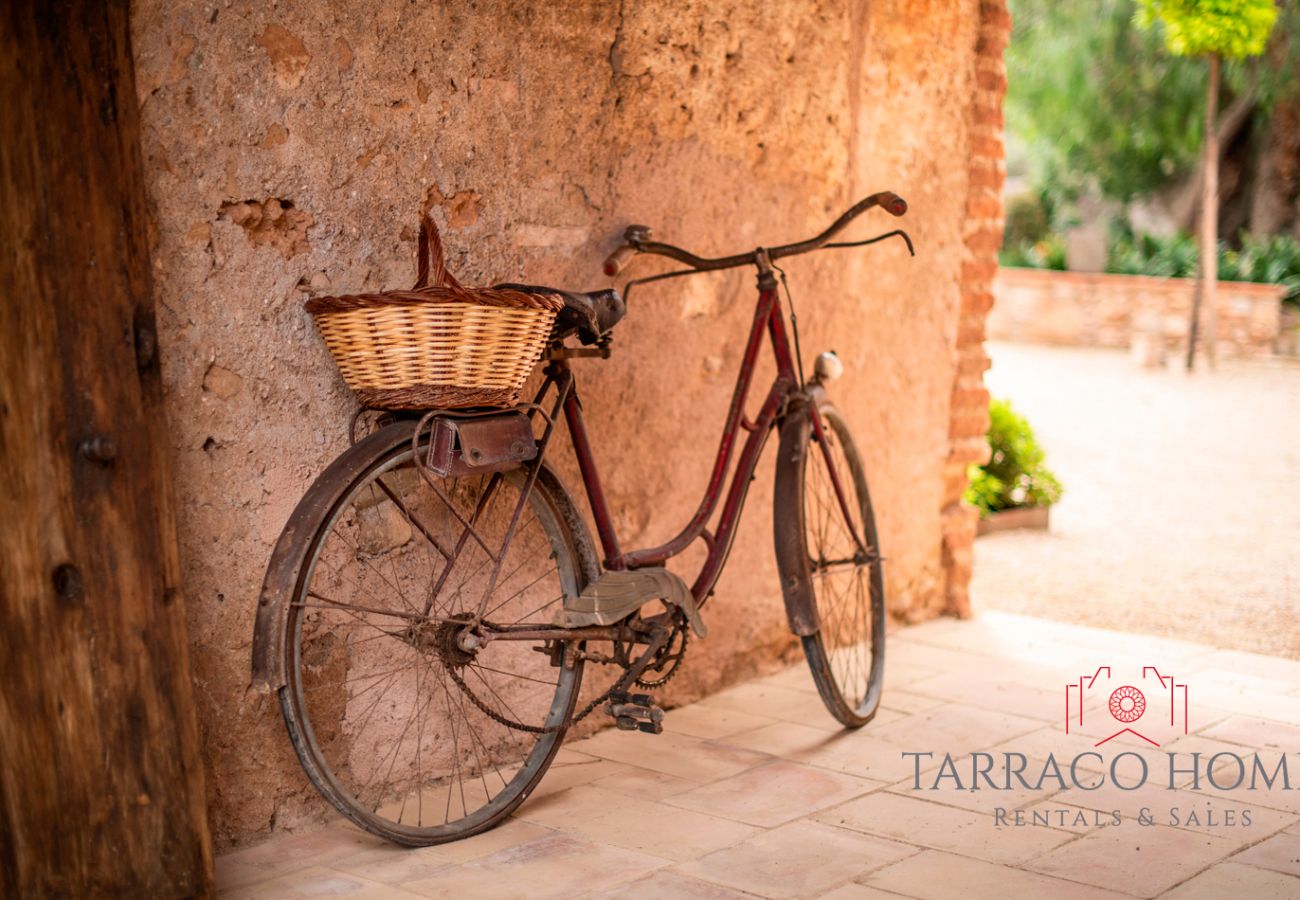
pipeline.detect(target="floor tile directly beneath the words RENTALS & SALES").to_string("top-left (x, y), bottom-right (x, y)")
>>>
top-left (1026, 823), bottom-right (1232, 897)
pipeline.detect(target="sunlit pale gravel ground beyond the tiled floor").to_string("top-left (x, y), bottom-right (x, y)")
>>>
top-left (972, 343), bottom-right (1300, 658)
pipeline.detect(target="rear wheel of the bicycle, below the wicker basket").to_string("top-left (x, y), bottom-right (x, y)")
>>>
top-left (280, 421), bottom-right (595, 845)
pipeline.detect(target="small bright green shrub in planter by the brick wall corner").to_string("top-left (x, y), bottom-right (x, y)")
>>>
top-left (966, 401), bottom-right (1062, 516)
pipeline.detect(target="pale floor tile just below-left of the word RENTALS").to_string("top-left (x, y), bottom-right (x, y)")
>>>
top-left (813, 792), bottom-right (1074, 864)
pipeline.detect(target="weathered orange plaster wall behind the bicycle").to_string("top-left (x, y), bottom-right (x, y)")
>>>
top-left (134, 0), bottom-right (982, 845)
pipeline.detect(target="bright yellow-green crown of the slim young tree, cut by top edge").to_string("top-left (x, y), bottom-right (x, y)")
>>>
top-left (1138, 0), bottom-right (1278, 60)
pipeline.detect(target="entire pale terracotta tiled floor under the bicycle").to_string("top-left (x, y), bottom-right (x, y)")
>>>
top-left (217, 613), bottom-right (1300, 900)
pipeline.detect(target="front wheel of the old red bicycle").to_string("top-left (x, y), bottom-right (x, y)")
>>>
top-left (775, 391), bottom-right (885, 728)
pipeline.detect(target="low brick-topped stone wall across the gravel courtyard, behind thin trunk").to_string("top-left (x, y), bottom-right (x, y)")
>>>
top-left (988, 268), bottom-right (1284, 356)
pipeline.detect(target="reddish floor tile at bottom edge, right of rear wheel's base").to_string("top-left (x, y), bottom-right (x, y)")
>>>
top-left (403, 834), bottom-right (667, 900)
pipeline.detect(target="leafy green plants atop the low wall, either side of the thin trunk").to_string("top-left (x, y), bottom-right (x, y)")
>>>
top-left (1106, 224), bottom-right (1300, 303)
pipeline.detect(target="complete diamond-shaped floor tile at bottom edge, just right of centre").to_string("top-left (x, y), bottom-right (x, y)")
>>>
top-left (677, 822), bottom-right (917, 897)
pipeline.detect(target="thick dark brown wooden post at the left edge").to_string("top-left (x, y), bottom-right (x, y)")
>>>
top-left (0, 0), bottom-right (212, 897)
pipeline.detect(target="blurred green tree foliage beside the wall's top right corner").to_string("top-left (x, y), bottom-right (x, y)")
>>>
top-left (1006, 0), bottom-right (1206, 204)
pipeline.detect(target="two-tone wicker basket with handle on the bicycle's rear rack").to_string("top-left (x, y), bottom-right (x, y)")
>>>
top-left (307, 216), bottom-right (564, 410)
